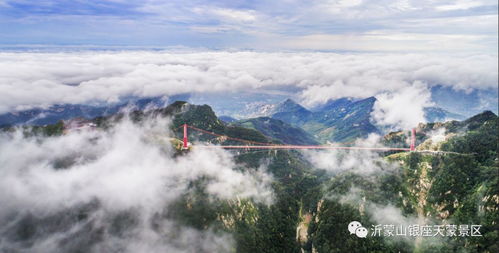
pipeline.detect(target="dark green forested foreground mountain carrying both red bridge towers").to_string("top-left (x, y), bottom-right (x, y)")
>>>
top-left (1, 101), bottom-right (499, 252)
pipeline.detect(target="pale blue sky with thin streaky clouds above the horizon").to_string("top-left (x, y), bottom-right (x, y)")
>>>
top-left (0, 0), bottom-right (498, 54)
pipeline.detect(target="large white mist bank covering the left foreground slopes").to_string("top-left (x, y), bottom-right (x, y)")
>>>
top-left (0, 115), bottom-right (273, 252)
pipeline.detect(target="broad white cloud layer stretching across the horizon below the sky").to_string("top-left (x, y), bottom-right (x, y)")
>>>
top-left (0, 51), bottom-right (498, 113)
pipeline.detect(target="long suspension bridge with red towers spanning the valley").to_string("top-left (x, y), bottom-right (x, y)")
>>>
top-left (177, 124), bottom-right (416, 152)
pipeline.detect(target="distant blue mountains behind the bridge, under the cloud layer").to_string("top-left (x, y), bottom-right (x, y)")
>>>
top-left (0, 97), bottom-right (472, 144)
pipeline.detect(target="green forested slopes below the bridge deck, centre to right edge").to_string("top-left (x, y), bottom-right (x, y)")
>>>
top-left (163, 105), bottom-right (498, 252)
